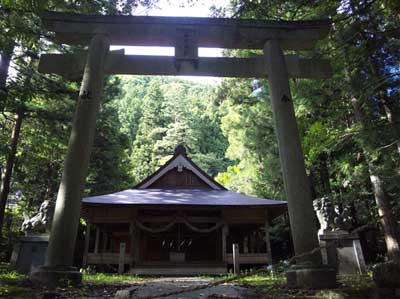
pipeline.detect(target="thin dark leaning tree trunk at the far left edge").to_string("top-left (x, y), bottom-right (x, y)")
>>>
top-left (0, 109), bottom-right (23, 237)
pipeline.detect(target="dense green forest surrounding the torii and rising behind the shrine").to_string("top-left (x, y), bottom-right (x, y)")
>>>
top-left (0, 0), bottom-right (400, 260)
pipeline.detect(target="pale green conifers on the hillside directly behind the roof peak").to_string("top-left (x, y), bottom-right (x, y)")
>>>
top-left (117, 77), bottom-right (228, 185)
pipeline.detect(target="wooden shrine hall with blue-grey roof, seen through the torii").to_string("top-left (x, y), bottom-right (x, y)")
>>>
top-left (82, 146), bottom-right (286, 275)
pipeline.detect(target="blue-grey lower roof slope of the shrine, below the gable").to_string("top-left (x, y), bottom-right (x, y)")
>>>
top-left (82, 189), bottom-right (286, 207)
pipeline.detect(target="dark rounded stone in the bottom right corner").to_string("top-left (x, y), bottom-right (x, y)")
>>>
top-left (372, 261), bottom-right (400, 288)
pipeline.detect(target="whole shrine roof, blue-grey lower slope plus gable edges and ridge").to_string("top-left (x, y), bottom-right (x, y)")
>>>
top-left (82, 145), bottom-right (287, 219)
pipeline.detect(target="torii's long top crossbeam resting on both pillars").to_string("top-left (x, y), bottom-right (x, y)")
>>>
top-left (42, 12), bottom-right (330, 50)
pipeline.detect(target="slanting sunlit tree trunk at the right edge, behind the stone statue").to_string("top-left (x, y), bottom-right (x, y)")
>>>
top-left (351, 98), bottom-right (400, 261)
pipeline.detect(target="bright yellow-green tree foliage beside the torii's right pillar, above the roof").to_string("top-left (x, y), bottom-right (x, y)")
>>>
top-left (217, 79), bottom-right (283, 198)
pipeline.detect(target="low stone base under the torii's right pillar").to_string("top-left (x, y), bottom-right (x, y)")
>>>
top-left (286, 265), bottom-right (337, 289)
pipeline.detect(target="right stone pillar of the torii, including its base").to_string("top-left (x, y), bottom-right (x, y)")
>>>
top-left (264, 40), bottom-right (336, 289)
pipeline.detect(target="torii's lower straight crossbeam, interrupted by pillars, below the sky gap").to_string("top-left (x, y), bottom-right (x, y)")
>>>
top-left (39, 51), bottom-right (332, 79)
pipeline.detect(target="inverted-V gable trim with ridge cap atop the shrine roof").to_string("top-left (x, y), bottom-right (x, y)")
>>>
top-left (134, 145), bottom-right (226, 190)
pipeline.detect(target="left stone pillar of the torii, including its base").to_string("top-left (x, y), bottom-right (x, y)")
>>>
top-left (31, 34), bottom-right (110, 286)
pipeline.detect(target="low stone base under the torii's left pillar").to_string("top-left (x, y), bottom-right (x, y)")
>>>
top-left (30, 266), bottom-right (82, 288)
